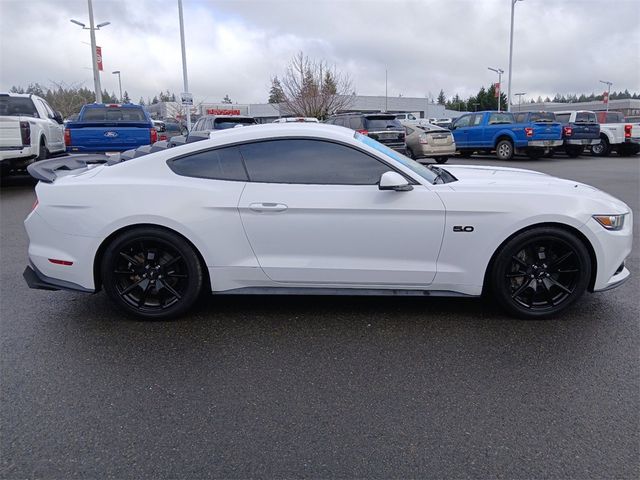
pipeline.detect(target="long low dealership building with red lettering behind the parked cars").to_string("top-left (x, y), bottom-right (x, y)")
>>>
top-left (145, 95), bottom-right (464, 123)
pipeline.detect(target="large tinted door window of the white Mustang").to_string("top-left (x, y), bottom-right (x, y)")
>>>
top-left (240, 139), bottom-right (392, 185)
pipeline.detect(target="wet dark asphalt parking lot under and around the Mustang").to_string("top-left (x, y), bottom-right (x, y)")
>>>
top-left (0, 156), bottom-right (640, 479)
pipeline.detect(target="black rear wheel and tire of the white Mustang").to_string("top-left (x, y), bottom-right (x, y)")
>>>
top-left (100, 227), bottom-right (204, 320)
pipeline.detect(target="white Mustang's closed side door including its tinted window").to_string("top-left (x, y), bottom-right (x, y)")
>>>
top-left (239, 139), bottom-right (444, 288)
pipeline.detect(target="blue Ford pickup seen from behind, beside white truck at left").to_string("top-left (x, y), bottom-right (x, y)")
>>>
top-left (64, 103), bottom-right (158, 153)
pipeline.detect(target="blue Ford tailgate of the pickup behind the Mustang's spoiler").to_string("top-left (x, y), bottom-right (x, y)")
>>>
top-left (68, 123), bottom-right (151, 152)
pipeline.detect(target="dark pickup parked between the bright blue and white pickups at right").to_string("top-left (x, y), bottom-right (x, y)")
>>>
top-left (516, 110), bottom-right (600, 158)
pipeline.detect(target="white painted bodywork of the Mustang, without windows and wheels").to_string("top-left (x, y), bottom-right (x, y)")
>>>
top-left (25, 123), bottom-right (633, 295)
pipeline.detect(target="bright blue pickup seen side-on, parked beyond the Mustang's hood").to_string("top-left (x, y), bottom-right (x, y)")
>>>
top-left (451, 111), bottom-right (563, 160)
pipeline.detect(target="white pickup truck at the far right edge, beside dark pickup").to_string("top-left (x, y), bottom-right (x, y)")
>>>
top-left (591, 112), bottom-right (640, 157)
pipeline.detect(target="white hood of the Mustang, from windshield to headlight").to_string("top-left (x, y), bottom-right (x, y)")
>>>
top-left (440, 165), bottom-right (630, 213)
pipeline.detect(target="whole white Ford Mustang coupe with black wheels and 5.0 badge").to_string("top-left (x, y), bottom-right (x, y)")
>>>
top-left (24, 123), bottom-right (632, 319)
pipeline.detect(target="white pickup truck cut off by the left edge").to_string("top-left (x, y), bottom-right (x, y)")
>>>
top-left (0, 93), bottom-right (66, 174)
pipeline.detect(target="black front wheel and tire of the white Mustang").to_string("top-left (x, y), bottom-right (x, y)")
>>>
top-left (490, 227), bottom-right (592, 320)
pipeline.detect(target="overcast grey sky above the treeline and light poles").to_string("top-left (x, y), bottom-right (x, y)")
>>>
top-left (0, 0), bottom-right (640, 103)
